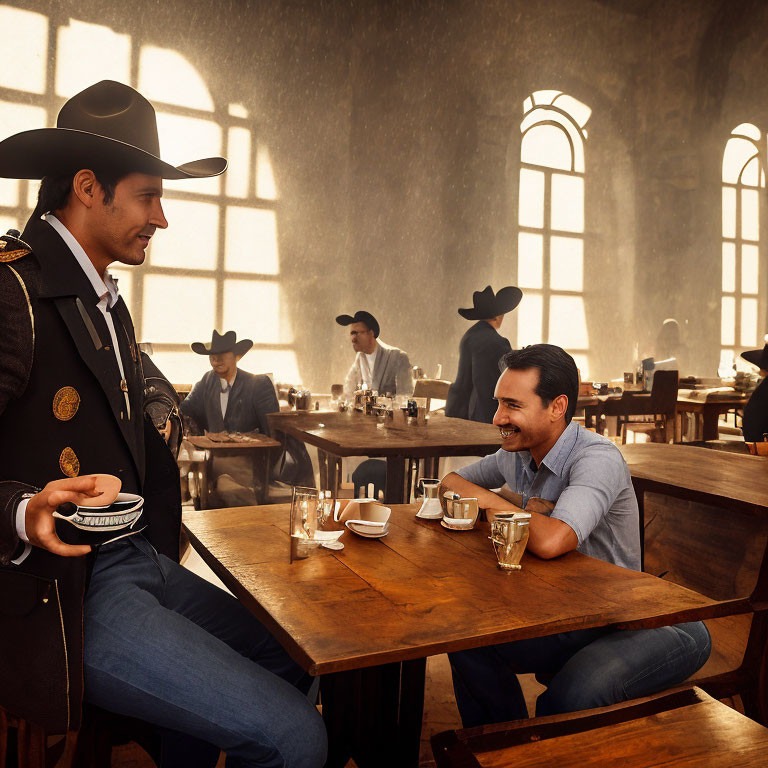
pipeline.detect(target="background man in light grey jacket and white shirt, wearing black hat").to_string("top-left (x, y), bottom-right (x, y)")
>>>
top-left (336, 310), bottom-right (413, 399)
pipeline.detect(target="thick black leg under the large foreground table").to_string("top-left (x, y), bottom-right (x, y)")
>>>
top-left (320, 659), bottom-right (426, 768)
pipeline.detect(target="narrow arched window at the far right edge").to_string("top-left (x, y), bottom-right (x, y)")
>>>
top-left (719, 123), bottom-right (765, 375)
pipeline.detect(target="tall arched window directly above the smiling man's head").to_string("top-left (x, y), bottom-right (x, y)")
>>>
top-left (517, 91), bottom-right (592, 377)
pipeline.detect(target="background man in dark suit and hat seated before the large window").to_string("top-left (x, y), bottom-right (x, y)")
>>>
top-left (180, 330), bottom-right (314, 506)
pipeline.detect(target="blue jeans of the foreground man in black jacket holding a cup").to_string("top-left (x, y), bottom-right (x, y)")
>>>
top-left (84, 536), bottom-right (327, 768)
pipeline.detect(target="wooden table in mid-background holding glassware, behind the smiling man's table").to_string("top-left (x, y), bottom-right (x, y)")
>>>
top-left (267, 411), bottom-right (501, 504)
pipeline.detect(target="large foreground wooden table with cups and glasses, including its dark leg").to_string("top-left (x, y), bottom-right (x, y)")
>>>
top-left (184, 505), bottom-right (736, 768)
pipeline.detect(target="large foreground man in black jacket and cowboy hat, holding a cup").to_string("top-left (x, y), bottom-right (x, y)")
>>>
top-left (0, 81), bottom-right (326, 766)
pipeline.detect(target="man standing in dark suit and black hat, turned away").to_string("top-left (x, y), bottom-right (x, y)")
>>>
top-left (445, 285), bottom-right (523, 424)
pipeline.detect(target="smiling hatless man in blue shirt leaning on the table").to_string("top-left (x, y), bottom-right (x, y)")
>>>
top-left (441, 344), bottom-right (710, 727)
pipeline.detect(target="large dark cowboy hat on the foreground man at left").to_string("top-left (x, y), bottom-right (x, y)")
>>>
top-left (0, 80), bottom-right (227, 179)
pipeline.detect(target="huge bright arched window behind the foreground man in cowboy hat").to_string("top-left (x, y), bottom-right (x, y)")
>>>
top-left (0, 5), bottom-right (300, 384)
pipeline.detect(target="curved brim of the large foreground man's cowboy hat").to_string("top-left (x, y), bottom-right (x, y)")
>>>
top-left (0, 128), bottom-right (227, 179)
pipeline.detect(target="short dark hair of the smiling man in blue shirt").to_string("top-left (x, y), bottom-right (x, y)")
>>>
top-left (499, 344), bottom-right (579, 424)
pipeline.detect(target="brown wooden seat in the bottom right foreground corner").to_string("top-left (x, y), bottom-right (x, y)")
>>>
top-left (432, 688), bottom-right (768, 768)
